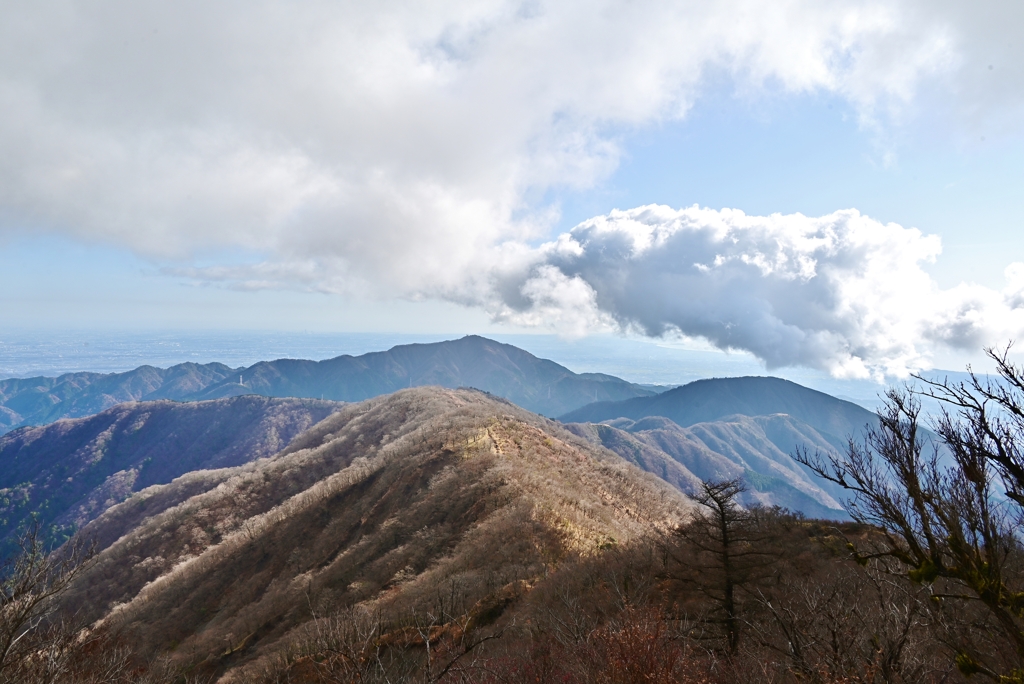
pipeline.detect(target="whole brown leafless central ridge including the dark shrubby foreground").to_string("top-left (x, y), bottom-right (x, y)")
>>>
top-left (2, 370), bottom-right (1021, 684)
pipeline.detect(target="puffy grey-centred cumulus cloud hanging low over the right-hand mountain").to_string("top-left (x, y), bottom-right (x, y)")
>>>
top-left (494, 206), bottom-right (1024, 378)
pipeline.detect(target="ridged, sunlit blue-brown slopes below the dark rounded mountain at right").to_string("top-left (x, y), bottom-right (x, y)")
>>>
top-left (565, 414), bottom-right (848, 519)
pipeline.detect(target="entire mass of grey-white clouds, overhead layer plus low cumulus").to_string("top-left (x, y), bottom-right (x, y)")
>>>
top-left (0, 0), bottom-right (1024, 373)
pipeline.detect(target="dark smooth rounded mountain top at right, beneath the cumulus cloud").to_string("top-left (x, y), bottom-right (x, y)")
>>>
top-left (559, 377), bottom-right (878, 448)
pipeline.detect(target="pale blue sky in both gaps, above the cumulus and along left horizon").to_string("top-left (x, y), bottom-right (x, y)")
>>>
top-left (9, 91), bottom-right (1024, 317)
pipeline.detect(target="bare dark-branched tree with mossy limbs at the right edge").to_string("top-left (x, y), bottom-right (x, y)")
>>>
top-left (797, 358), bottom-right (1024, 682)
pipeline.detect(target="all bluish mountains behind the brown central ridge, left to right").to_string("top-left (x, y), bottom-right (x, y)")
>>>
top-left (0, 336), bottom-right (888, 528)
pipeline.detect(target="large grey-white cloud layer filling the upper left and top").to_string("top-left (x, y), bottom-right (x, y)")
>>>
top-left (0, 0), bottom-right (970, 255)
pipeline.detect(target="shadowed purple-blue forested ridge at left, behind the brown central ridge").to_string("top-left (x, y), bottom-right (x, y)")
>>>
top-left (0, 395), bottom-right (343, 556)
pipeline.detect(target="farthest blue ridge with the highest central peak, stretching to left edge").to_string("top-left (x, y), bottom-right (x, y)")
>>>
top-left (0, 335), bottom-right (655, 433)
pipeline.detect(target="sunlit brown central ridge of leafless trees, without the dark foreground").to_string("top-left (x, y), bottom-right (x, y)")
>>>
top-left (61, 388), bottom-right (690, 683)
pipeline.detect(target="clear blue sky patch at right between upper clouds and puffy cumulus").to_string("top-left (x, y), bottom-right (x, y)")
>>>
top-left (562, 84), bottom-right (1024, 287)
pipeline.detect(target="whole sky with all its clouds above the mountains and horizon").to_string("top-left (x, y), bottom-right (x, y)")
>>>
top-left (0, 0), bottom-right (1024, 380)
